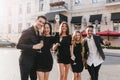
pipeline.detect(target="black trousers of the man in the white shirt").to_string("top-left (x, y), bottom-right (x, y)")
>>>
top-left (88, 64), bottom-right (101, 80)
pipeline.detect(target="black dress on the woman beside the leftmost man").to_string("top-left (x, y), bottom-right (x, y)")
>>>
top-left (36, 36), bottom-right (55, 72)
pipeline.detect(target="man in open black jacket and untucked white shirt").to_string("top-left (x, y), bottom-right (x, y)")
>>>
top-left (84, 25), bottom-right (109, 80)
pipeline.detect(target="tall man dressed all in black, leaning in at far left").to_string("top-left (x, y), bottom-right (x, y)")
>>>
top-left (17, 16), bottom-right (46, 80)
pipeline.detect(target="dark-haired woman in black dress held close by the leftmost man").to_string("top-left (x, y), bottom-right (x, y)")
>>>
top-left (36, 23), bottom-right (55, 80)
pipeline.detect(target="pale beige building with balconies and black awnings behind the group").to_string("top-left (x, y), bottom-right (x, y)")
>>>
top-left (3, 0), bottom-right (120, 46)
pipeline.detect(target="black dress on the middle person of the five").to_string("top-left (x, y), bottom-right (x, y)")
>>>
top-left (57, 35), bottom-right (71, 64)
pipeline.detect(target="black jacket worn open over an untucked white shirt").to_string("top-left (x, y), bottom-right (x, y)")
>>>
top-left (84, 35), bottom-right (105, 60)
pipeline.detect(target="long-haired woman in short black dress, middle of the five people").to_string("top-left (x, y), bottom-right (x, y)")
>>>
top-left (55, 22), bottom-right (71, 80)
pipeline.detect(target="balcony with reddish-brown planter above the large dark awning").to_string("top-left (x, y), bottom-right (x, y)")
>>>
top-left (50, 1), bottom-right (68, 12)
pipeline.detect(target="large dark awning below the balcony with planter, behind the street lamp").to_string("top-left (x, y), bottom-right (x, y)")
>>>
top-left (45, 12), bottom-right (67, 23)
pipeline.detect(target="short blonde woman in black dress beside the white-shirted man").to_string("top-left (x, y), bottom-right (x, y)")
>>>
top-left (71, 31), bottom-right (84, 80)
